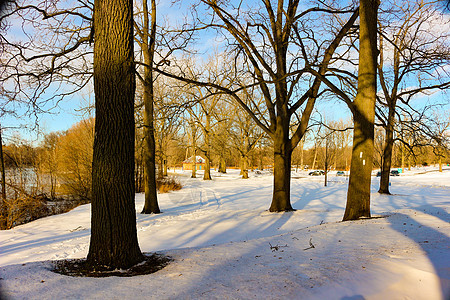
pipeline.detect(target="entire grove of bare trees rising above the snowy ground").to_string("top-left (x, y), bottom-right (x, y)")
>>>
top-left (0, 0), bottom-right (450, 269)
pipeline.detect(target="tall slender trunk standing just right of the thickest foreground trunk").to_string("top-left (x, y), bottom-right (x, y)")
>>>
top-left (141, 0), bottom-right (161, 214)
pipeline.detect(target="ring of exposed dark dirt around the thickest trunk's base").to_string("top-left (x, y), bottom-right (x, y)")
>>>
top-left (52, 253), bottom-right (172, 277)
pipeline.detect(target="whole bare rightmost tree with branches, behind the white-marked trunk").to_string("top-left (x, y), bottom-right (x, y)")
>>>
top-left (377, 0), bottom-right (450, 194)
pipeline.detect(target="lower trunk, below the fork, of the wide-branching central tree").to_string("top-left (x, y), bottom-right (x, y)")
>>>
top-left (269, 122), bottom-right (293, 212)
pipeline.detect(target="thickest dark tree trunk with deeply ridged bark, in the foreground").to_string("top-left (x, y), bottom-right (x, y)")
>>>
top-left (87, 0), bottom-right (144, 269)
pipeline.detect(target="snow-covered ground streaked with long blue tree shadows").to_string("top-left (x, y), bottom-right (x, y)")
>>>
top-left (0, 167), bottom-right (450, 299)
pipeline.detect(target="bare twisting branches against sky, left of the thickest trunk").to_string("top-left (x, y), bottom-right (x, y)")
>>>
top-left (0, 0), bottom-right (93, 123)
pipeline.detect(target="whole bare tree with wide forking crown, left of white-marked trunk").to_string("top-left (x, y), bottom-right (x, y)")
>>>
top-left (158, 0), bottom-right (358, 212)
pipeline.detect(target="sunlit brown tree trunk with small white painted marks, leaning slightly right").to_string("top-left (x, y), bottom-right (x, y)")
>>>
top-left (343, 0), bottom-right (379, 221)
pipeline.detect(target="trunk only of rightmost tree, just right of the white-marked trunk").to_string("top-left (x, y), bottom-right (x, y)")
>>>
top-left (378, 108), bottom-right (395, 194)
